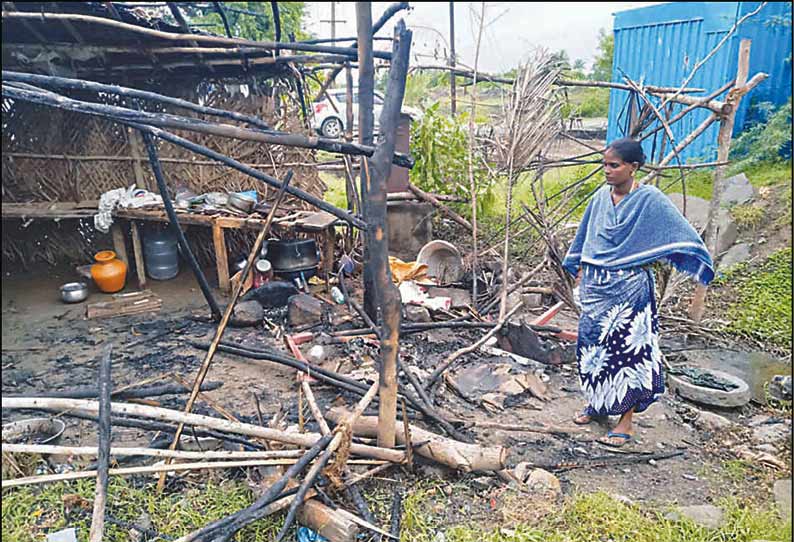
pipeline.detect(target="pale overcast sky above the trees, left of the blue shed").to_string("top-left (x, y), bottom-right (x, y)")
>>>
top-left (306, 2), bottom-right (661, 73)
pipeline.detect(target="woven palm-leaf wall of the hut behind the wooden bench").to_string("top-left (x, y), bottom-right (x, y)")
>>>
top-left (2, 82), bottom-right (325, 269)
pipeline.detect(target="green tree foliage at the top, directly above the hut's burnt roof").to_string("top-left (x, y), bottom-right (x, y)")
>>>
top-left (180, 2), bottom-right (310, 41)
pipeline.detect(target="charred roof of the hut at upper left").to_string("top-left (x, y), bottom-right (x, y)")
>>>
top-left (2, 2), bottom-right (296, 82)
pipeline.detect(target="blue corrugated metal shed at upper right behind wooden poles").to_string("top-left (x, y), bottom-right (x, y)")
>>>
top-left (607, 2), bottom-right (792, 161)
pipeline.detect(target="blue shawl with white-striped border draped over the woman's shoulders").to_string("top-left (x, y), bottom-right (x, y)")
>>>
top-left (562, 185), bottom-right (714, 284)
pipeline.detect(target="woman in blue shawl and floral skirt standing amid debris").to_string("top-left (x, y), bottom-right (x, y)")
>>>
top-left (563, 139), bottom-right (714, 446)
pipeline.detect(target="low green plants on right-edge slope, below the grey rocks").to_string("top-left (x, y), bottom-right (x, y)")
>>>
top-left (717, 247), bottom-right (792, 350)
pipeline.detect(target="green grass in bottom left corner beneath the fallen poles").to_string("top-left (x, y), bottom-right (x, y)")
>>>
top-left (2, 477), bottom-right (284, 542)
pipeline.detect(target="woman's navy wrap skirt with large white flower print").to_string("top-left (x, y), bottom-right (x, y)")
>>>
top-left (577, 265), bottom-right (664, 416)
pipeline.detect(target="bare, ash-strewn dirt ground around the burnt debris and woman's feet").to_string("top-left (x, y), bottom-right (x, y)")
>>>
top-left (2, 270), bottom-right (790, 519)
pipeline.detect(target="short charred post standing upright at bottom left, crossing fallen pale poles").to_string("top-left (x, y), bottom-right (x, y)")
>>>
top-left (88, 344), bottom-right (113, 542)
